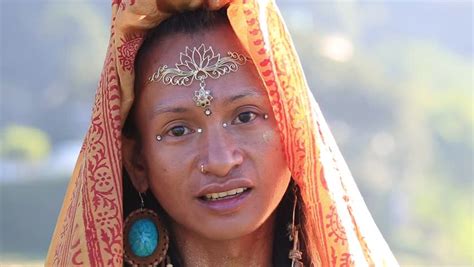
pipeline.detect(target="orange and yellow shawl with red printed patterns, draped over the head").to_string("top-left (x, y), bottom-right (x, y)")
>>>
top-left (46, 0), bottom-right (398, 266)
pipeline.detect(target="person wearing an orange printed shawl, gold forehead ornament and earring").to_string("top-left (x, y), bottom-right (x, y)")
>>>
top-left (47, 1), bottom-right (396, 266)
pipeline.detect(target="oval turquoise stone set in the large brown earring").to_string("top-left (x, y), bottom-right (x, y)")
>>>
top-left (128, 218), bottom-right (159, 257)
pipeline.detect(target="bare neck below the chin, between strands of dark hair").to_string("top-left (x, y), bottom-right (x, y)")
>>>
top-left (172, 214), bottom-right (275, 267)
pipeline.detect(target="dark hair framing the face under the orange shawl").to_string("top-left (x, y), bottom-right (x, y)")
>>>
top-left (122, 9), bottom-right (307, 267)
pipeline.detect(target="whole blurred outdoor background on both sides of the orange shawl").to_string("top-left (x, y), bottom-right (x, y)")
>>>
top-left (0, 0), bottom-right (474, 266)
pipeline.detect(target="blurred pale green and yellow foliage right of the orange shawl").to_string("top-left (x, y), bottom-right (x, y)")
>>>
top-left (289, 2), bottom-right (474, 266)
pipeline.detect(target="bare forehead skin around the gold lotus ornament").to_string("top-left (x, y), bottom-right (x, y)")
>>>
top-left (137, 25), bottom-right (265, 113)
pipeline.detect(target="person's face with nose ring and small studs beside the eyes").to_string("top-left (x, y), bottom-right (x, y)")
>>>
top-left (125, 23), bottom-right (290, 240)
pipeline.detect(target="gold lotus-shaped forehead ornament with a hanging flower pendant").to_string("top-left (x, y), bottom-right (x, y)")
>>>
top-left (148, 44), bottom-right (250, 116)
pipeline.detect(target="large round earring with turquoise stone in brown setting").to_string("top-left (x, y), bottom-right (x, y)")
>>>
top-left (123, 193), bottom-right (169, 266)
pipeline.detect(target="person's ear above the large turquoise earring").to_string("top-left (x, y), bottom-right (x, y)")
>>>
top-left (122, 135), bottom-right (148, 193)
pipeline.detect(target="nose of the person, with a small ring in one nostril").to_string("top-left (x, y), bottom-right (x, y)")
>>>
top-left (203, 128), bottom-right (244, 177)
